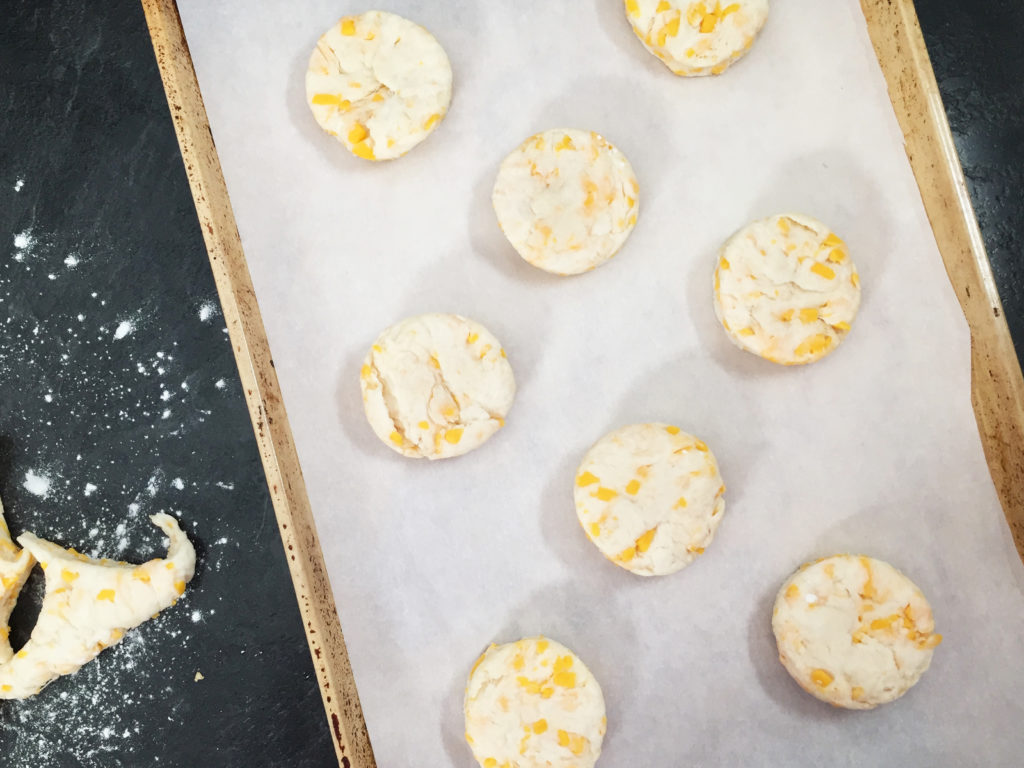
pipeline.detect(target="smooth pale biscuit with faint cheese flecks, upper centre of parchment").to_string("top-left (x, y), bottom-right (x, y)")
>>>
top-left (492, 128), bottom-right (640, 274)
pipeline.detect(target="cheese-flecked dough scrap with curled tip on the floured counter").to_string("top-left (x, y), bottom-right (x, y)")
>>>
top-left (0, 513), bottom-right (196, 698)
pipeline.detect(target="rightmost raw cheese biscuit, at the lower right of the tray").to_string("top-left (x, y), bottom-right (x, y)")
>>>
top-left (772, 555), bottom-right (942, 710)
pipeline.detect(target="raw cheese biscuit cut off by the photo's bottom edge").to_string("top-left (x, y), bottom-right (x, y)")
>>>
top-left (464, 637), bottom-right (607, 768)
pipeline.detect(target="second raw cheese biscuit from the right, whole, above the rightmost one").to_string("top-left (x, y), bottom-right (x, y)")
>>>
top-left (715, 214), bottom-right (860, 366)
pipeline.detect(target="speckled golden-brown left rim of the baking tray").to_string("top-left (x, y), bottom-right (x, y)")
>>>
top-left (142, 0), bottom-right (376, 768)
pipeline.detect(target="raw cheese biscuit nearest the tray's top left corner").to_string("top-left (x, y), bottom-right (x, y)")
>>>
top-left (306, 10), bottom-right (452, 160)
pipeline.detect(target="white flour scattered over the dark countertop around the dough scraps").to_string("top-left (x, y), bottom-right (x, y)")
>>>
top-left (0, 219), bottom-right (237, 766)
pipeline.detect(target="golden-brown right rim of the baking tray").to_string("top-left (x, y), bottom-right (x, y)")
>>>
top-left (860, 0), bottom-right (1024, 560)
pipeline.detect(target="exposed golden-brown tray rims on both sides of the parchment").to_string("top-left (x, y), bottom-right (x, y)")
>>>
top-left (142, 0), bottom-right (1024, 768)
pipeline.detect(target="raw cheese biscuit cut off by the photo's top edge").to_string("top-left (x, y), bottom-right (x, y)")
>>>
top-left (626, 0), bottom-right (768, 77)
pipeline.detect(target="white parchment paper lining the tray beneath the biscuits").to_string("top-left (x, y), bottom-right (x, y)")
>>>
top-left (179, 0), bottom-right (1024, 768)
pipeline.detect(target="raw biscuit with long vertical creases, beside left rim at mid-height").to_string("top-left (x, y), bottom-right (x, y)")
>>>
top-left (359, 314), bottom-right (515, 459)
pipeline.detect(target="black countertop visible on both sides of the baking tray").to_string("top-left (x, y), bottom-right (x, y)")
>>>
top-left (0, 0), bottom-right (1024, 768)
